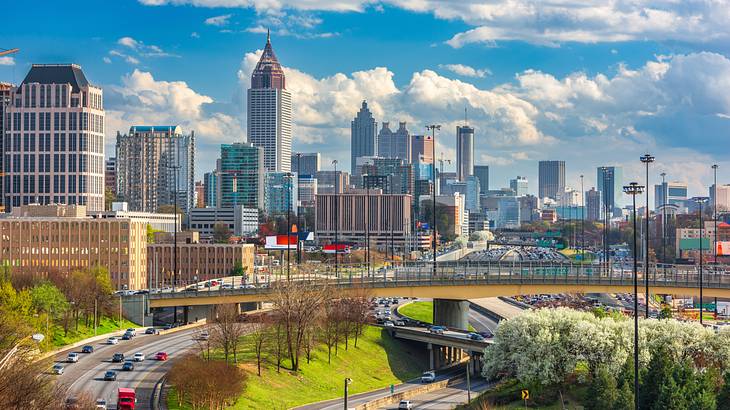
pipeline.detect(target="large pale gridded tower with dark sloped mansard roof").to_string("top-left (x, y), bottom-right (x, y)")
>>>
top-left (2, 64), bottom-right (104, 211)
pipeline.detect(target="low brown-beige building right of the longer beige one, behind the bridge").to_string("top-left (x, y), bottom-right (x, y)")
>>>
top-left (147, 242), bottom-right (255, 288)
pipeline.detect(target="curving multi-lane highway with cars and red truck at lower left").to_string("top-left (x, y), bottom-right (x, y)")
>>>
top-left (55, 329), bottom-right (198, 409)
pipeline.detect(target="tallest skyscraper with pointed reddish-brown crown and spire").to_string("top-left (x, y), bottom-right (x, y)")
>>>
top-left (247, 34), bottom-right (292, 172)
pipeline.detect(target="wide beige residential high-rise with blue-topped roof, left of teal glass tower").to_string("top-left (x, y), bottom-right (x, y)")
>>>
top-left (116, 125), bottom-right (195, 213)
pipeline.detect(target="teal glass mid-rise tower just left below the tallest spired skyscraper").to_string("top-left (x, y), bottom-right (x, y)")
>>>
top-left (217, 143), bottom-right (265, 209)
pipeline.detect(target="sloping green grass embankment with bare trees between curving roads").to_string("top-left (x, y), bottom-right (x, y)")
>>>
top-left (167, 326), bottom-right (427, 410)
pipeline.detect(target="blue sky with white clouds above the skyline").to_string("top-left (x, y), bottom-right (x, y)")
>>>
top-left (0, 0), bottom-right (730, 203)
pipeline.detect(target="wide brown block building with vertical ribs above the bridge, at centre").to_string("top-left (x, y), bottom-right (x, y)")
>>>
top-left (316, 189), bottom-right (412, 252)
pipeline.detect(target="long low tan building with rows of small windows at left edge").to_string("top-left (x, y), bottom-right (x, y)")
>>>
top-left (0, 205), bottom-right (147, 289)
